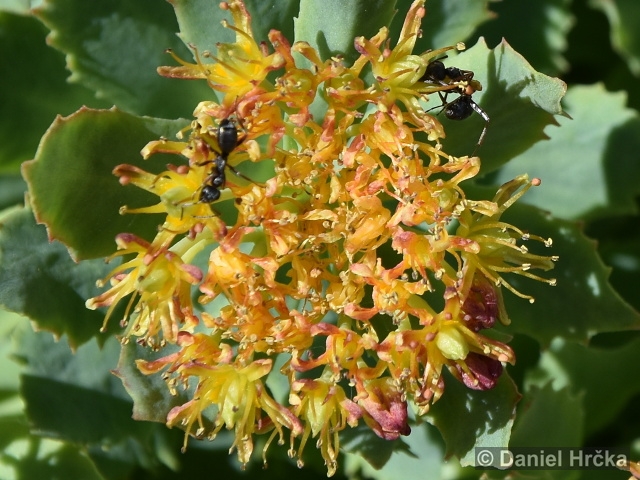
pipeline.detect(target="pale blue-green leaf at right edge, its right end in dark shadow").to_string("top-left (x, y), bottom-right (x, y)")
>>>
top-left (492, 84), bottom-right (640, 218)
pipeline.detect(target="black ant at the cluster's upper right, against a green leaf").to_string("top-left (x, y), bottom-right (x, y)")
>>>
top-left (420, 60), bottom-right (490, 155)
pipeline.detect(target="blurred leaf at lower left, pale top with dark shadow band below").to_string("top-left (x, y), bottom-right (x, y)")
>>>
top-left (16, 332), bottom-right (178, 471)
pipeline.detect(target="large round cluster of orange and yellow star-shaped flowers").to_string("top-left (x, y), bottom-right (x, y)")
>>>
top-left (87, 0), bottom-right (553, 475)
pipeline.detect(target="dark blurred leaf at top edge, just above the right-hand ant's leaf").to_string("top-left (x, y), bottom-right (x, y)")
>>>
top-left (475, 0), bottom-right (575, 75)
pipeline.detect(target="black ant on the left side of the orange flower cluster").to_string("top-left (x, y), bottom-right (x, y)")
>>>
top-left (200, 118), bottom-right (246, 203)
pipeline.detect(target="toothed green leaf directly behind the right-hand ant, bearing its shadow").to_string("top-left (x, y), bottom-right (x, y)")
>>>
top-left (427, 39), bottom-right (566, 169)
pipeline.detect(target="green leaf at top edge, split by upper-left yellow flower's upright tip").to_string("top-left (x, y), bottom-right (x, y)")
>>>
top-left (170, 0), bottom-right (300, 52)
